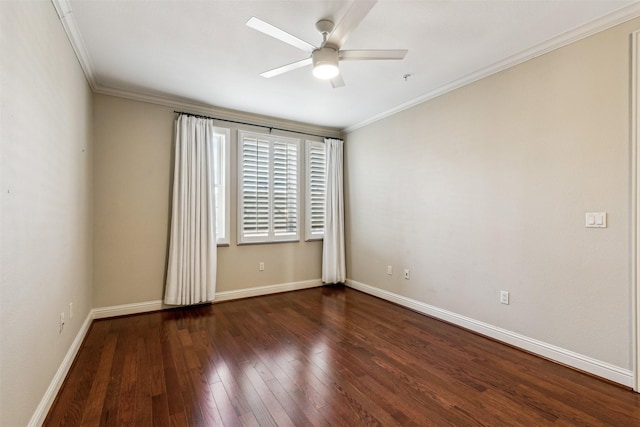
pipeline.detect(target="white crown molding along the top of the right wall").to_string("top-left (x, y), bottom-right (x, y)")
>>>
top-left (342, 1), bottom-right (640, 134)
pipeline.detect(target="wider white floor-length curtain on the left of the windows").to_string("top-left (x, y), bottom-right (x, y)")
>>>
top-left (164, 115), bottom-right (219, 305)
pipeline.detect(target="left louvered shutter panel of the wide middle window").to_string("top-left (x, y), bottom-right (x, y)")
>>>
top-left (241, 135), bottom-right (269, 240)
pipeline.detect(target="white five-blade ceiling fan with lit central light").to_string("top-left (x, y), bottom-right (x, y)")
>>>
top-left (247, 0), bottom-right (407, 88)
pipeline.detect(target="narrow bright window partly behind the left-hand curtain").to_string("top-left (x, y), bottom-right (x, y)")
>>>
top-left (213, 127), bottom-right (230, 245)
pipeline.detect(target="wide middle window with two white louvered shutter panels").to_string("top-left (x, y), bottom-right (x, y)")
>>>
top-left (238, 131), bottom-right (300, 243)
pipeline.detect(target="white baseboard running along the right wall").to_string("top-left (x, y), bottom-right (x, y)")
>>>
top-left (346, 279), bottom-right (634, 387)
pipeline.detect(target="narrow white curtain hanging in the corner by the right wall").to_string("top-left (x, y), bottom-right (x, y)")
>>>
top-left (322, 138), bottom-right (347, 283)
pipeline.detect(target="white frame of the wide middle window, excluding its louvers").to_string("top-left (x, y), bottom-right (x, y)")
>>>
top-left (236, 129), bottom-right (302, 245)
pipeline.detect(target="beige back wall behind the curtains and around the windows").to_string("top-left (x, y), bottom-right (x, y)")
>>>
top-left (93, 95), bottom-right (330, 307)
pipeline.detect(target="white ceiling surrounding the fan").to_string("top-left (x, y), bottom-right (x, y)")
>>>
top-left (54, 0), bottom-right (638, 129)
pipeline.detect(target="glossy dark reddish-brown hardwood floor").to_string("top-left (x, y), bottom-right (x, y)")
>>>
top-left (45, 287), bottom-right (640, 427)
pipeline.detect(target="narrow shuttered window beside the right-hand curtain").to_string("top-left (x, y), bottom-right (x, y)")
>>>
top-left (305, 141), bottom-right (326, 240)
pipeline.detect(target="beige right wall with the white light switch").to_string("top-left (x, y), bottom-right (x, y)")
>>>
top-left (345, 20), bottom-right (640, 369)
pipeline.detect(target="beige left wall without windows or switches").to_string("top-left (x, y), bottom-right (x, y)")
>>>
top-left (0, 1), bottom-right (93, 426)
